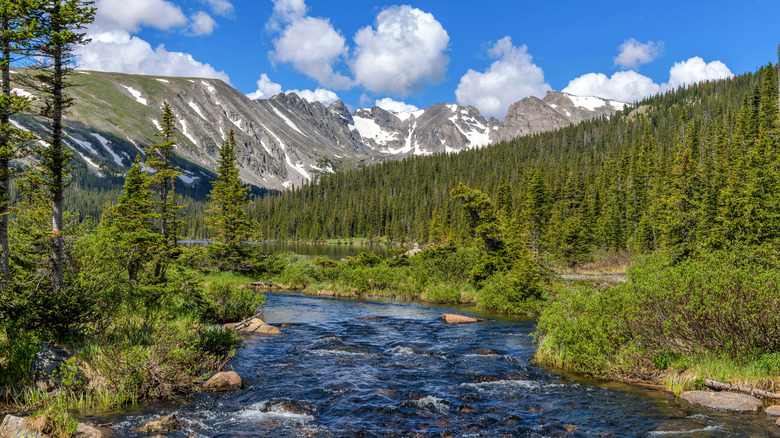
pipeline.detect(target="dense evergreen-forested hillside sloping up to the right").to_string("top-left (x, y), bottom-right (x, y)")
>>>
top-left (252, 64), bottom-right (780, 260)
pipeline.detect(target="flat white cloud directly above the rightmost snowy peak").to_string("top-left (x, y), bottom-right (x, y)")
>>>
top-left (562, 70), bottom-right (661, 102)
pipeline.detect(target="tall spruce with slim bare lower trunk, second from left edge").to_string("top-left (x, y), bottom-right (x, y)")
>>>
top-left (25, 0), bottom-right (96, 291)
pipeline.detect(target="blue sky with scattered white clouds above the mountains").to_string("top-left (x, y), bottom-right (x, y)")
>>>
top-left (76, 0), bottom-right (780, 119)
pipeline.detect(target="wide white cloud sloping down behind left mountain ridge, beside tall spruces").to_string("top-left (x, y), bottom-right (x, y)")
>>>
top-left (75, 30), bottom-right (230, 83)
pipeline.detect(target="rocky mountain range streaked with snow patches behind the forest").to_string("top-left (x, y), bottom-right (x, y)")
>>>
top-left (7, 71), bottom-right (627, 189)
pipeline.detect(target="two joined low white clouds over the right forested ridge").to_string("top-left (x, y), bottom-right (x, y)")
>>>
top-left (562, 56), bottom-right (734, 102)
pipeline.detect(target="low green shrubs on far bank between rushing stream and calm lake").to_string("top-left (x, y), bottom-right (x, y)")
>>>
top-left (263, 244), bottom-right (546, 314)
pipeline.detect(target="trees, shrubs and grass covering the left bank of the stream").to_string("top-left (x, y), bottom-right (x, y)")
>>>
top-left (0, 6), bottom-right (264, 437)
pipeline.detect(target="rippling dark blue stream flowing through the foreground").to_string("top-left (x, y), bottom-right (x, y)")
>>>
top-left (86, 293), bottom-right (780, 437)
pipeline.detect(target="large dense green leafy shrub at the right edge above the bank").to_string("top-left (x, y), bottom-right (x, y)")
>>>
top-left (615, 249), bottom-right (780, 358)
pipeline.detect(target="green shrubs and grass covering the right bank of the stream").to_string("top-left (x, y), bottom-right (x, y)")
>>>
top-left (536, 248), bottom-right (780, 393)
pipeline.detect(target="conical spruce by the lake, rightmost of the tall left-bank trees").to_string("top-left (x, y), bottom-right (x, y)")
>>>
top-left (207, 129), bottom-right (251, 247)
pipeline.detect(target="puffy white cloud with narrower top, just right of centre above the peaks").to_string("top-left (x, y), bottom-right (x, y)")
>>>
top-left (455, 36), bottom-right (552, 119)
